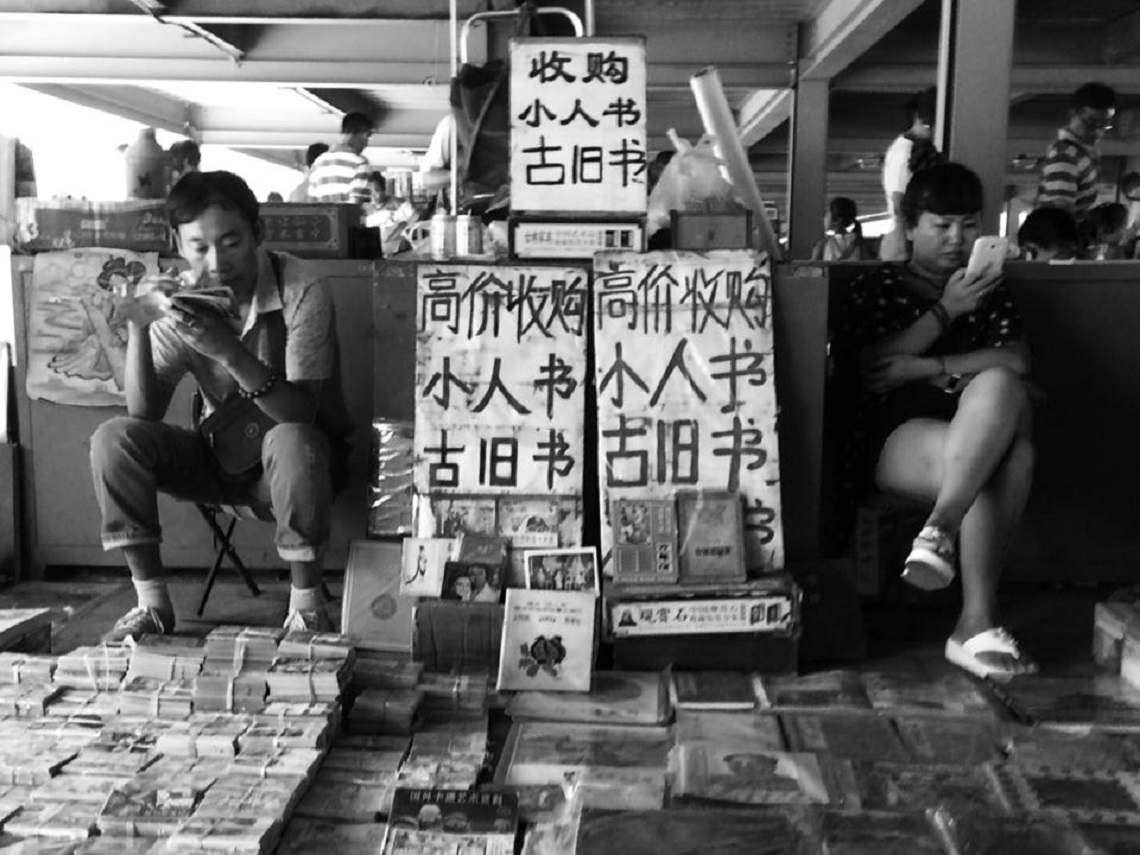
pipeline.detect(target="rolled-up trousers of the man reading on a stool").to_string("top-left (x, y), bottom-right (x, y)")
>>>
top-left (91, 416), bottom-right (342, 561)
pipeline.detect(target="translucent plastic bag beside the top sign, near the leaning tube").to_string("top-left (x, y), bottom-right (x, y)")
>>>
top-left (646, 128), bottom-right (742, 236)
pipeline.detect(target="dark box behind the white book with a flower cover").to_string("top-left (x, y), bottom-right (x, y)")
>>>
top-left (412, 600), bottom-right (504, 673)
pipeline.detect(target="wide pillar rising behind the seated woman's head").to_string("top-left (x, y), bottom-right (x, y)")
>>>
top-left (938, 0), bottom-right (1017, 235)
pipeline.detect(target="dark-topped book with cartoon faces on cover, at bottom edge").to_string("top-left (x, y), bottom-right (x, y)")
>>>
top-left (383, 789), bottom-right (519, 855)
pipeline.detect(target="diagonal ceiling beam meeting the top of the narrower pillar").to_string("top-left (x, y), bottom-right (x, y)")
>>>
top-left (799, 0), bottom-right (922, 80)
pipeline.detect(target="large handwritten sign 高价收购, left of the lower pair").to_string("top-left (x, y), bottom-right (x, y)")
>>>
top-left (414, 264), bottom-right (589, 508)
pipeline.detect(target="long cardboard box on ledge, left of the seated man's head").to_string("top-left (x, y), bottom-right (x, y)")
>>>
top-left (16, 198), bottom-right (173, 252)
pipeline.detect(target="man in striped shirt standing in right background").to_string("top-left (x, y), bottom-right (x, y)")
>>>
top-left (1037, 83), bottom-right (1116, 220)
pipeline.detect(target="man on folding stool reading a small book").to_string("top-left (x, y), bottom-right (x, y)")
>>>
top-left (91, 172), bottom-right (351, 641)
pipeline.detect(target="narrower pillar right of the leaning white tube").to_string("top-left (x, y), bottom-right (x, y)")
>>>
top-left (788, 80), bottom-right (831, 259)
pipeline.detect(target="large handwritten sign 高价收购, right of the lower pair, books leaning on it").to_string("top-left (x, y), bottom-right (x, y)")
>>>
top-left (594, 250), bottom-right (783, 575)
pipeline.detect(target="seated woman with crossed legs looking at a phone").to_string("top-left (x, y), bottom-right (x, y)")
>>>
top-left (845, 163), bottom-right (1036, 676)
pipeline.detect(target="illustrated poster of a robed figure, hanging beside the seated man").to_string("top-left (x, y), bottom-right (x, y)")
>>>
top-left (27, 249), bottom-right (158, 407)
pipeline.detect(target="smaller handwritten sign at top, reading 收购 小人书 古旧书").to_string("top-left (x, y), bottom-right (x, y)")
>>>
top-left (511, 38), bottom-right (646, 214)
